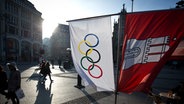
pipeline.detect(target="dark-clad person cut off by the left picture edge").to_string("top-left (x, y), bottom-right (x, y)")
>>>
top-left (0, 65), bottom-right (8, 97)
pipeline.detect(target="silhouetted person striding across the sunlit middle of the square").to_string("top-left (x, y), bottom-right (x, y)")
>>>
top-left (43, 62), bottom-right (53, 82)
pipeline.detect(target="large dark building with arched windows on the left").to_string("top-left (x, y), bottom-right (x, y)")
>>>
top-left (0, 0), bottom-right (43, 63)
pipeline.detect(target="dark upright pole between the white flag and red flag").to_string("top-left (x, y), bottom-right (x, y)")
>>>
top-left (115, 4), bottom-right (126, 104)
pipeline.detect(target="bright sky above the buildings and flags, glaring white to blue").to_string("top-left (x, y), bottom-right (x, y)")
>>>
top-left (29, 0), bottom-right (180, 38)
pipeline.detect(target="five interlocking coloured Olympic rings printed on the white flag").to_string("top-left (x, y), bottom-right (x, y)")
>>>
top-left (78, 34), bottom-right (103, 78)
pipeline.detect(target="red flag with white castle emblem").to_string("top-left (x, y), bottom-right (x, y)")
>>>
top-left (118, 9), bottom-right (184, 93)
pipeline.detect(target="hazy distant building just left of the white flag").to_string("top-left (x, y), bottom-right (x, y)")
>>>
top-left (50, 24), bottom-right (71, 60)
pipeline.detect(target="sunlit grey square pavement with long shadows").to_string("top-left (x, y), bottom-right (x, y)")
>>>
top-left (0, 65), bottom-right (153, 104)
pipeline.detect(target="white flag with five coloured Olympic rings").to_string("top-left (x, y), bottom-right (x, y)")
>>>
top-left (69, 17), bottom-right (115, 91)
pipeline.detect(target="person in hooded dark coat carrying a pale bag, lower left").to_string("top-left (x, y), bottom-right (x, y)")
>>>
top-left (7, 62), bottom-right (21, 104)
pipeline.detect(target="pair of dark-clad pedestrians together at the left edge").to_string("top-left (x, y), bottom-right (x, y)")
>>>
top-left (0, 62), bottom-right (21, 104)
